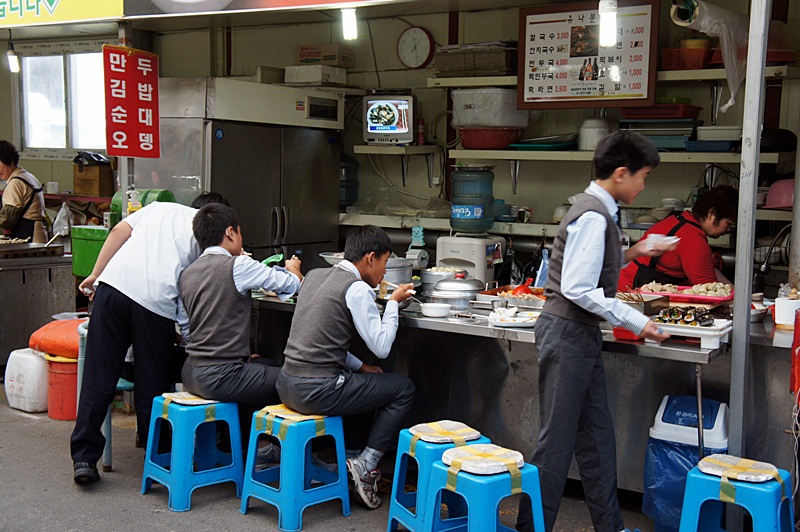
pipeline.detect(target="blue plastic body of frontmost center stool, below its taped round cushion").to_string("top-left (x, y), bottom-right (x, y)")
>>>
top-left (420, 460), bottom-right (544, 532)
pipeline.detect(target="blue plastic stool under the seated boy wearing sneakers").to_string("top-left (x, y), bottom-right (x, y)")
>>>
top-left (240, 405), bottom-right (350, 532)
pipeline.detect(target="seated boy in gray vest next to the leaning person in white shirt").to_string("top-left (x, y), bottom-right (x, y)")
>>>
top-left (178, 204), bottom-right (303, 408)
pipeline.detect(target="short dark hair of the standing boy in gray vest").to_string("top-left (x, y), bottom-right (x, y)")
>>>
top-left (594, 129), bottom-right (660, 179)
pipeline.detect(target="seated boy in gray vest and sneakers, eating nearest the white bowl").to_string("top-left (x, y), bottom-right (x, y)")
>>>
top-left (277, 226), bottom-right (414, 509)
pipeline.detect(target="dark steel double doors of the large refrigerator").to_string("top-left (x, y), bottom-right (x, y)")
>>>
top-left (207, 121), bottom-right (340, 271)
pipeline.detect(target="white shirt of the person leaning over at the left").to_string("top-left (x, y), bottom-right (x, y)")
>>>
top-left (97, 202), bottom-right (200, 337)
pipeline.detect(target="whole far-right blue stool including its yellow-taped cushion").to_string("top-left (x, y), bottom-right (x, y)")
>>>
top-left (680, 454), bottom-right (794, 532)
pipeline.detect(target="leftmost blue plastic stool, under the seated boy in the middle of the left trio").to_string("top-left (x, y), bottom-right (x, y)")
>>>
top-left (142, 396), bottom-right (244, 512)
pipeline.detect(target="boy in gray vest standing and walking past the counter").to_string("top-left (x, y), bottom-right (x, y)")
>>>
top-left (517, 131), bottom-right (674, 532)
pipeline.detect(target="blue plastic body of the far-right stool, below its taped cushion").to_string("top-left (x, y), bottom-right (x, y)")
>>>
top-left (680, 467), bottom-right (794, 532)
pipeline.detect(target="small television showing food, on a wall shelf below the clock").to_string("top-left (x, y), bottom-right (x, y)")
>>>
top-left (362, 94), bottom-right (414, 145)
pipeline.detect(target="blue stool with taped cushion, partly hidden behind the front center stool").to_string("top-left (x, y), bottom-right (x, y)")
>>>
top-left (387, 420), bottom-right (491, 530)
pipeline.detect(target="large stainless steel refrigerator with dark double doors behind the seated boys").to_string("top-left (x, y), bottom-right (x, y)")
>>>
top-left (133, 78), bottom-right (344, 272)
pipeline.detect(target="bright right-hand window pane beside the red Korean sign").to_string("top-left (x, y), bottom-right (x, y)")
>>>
top-left (68, 53), bottom-right (106, 150)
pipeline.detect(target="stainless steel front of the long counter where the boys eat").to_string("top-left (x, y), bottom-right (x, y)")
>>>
top-left (253, 300), bottom-right (793, 491)
